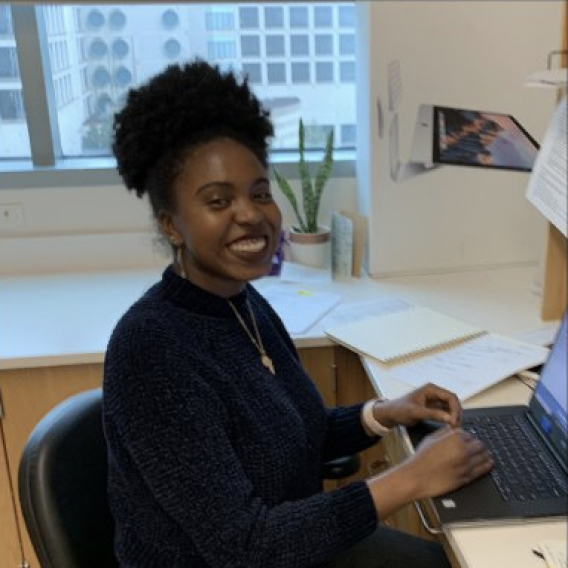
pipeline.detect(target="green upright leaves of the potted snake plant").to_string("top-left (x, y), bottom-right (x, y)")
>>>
top-left (274, 119), bottom-right (333, 233)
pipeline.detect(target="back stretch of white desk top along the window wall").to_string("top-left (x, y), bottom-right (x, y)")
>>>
top-left (0, 266), bottom-right (552, 369)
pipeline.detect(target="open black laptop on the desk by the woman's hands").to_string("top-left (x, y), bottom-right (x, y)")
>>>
top-left (404, 314), bottom-right (568, 526)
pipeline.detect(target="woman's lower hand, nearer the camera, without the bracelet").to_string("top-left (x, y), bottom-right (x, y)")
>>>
top-left (405, 426), bottom-right (493, 499)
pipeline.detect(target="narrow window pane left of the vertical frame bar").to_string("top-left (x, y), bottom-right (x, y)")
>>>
top-left (0, 5), bottom-right (31, 159)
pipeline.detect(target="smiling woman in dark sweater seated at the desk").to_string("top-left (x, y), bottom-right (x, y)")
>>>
top-left (104, 60), bottom-right (491, 568)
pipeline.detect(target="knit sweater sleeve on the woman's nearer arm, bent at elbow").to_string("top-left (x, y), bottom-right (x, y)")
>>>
top-left (105, 320), bottom-right (377, 568)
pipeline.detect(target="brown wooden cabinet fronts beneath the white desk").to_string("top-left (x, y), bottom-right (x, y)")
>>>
top-left (0, 346), bottom-right (415, 568)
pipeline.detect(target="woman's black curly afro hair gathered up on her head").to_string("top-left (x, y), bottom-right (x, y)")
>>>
top-left (112, 59), bottom-right (274, 210)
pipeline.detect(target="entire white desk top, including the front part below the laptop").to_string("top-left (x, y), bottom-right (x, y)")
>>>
top-left (0, 266), bottom-right (566, 568)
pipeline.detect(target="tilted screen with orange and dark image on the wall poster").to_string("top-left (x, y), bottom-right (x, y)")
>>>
top-left (433, 106), bottom-right (539, 172)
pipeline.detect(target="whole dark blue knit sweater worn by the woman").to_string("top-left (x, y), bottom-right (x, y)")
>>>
top-left (103, 267), bottom-right (377, 568)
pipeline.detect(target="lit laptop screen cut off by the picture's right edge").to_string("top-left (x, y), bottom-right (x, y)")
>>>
top-left (529, 314), bottom-right (568, 467)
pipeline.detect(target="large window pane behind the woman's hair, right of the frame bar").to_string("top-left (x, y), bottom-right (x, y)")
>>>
top-left (31, 2), bottom-right (356, 157)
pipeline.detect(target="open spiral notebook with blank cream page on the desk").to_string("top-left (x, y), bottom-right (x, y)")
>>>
top-left (325, 306), bottom-right (486, 363)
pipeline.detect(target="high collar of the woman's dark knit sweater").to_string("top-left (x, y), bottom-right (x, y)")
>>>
top-left (159, 264), bottom-right (252, 318)
